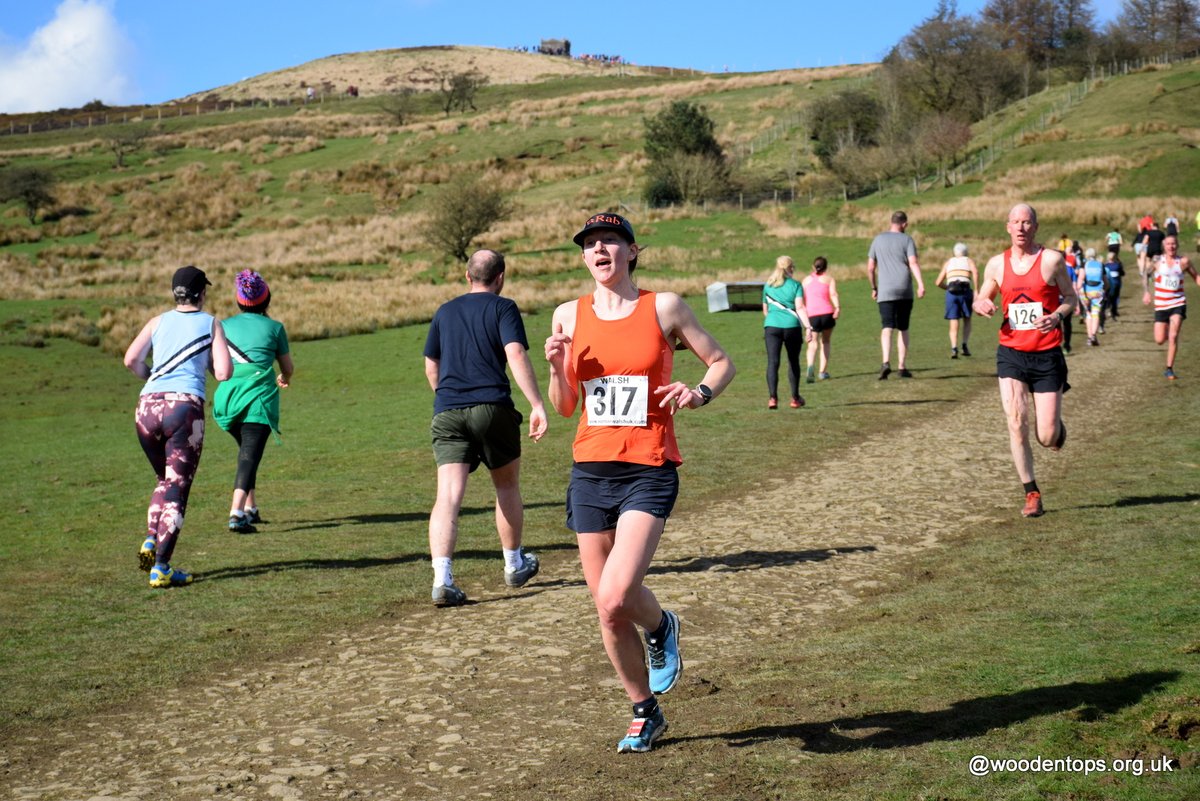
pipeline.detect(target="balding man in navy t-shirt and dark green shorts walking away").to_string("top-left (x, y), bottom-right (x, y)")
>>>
top-left (425, 251), bottom-right (547, 607)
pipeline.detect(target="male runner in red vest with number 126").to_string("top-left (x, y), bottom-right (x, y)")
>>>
top-left (974, 203), bottom-right (1079, 517)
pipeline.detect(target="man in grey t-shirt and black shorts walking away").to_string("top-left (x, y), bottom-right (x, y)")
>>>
top-left (866, 211), bottom-right (925, 381)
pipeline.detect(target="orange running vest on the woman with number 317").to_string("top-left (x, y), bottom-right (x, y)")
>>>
top-left (571, 290), bottom-right (683, 466)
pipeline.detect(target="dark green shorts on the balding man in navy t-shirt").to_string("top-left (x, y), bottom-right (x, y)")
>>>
top-left (430, 403), bottom-right (523, 472)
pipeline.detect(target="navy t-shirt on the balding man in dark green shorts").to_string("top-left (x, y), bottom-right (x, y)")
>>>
top-left (425, 293), bottom-right (529, 414)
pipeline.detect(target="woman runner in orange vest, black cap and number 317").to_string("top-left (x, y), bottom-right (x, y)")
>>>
top-left (546, 213), bottom-right (734, 753)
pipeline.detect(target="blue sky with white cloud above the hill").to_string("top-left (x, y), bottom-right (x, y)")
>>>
top-left (0, 0), bottom-right (1120, 113)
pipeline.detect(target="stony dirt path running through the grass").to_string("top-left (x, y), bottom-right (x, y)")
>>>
top-left (0, 309), bottom-right (1159, 801)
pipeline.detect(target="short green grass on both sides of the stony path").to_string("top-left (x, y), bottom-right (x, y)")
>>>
top-left (0, 281), bottom-right (1200, 800)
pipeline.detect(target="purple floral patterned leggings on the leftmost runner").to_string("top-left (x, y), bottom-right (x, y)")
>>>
top-left (134, 392), bottom-right (204, 565)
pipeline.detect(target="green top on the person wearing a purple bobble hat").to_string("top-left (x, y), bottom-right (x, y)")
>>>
top-left (212, 312), bottom-right (289, 433)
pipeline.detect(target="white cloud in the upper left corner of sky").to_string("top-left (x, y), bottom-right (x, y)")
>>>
top-left (0, 0), bottom-right (136, 113)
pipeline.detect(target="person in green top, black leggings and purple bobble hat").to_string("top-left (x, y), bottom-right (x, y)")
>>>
top-left (212, 270), bottom-right (293, 534)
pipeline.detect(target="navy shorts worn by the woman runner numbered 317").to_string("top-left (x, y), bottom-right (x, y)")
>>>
top-left (566, 462), bottom-right (679, 534)
